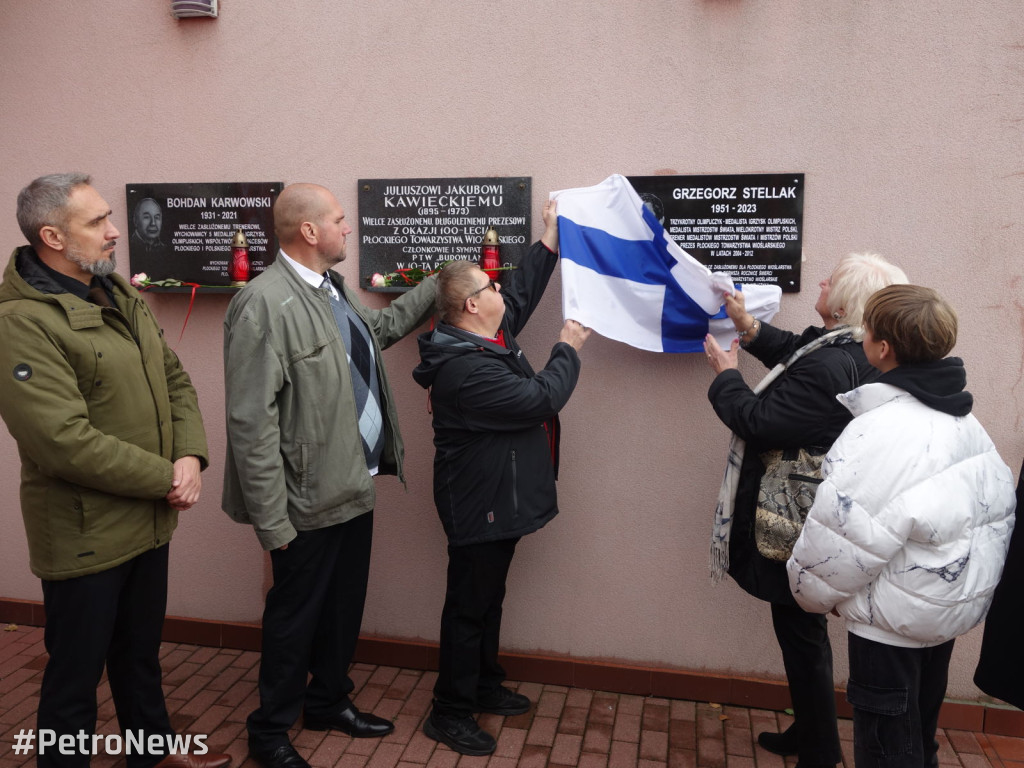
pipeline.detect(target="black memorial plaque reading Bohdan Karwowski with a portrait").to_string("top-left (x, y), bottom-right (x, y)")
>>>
top-left (125, 181), bottom-right (284, 291)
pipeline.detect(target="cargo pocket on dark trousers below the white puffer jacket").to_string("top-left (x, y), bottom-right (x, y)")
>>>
top-left (846, 680), bottom-right (913, 758)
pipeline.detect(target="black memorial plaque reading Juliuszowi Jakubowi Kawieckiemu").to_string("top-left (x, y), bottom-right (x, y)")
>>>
top-left (358, 176), bottom-right (531, 292)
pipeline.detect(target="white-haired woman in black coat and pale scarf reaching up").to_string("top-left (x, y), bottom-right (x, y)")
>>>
top-left (705, 254), bottom-right (907, 768)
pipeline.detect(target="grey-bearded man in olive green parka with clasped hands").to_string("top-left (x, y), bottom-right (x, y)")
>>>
top-left (0, 174), bottom-right (229, 768)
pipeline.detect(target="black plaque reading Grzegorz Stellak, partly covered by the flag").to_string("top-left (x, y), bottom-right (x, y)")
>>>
top-left (629, 173), bottom-right (804, 293)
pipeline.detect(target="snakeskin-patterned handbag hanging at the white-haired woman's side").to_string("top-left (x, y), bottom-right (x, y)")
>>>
top-left (754, 449), bottom-right (827, 562)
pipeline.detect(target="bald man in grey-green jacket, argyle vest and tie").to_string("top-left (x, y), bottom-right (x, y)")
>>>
top-left (223, 184), bottom-right (434, 768)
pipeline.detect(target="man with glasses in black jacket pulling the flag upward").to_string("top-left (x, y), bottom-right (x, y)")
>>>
top-left (413, 202), bottom-right (590, 755)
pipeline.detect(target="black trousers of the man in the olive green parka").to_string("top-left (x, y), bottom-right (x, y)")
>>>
top-left (37, 546), bottom-right (173, 768)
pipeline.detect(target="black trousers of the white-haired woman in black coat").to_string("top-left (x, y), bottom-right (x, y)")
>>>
top-left (771, 603), bottom-right (843, 766)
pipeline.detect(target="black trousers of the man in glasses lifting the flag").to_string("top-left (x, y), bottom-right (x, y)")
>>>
top-left (434, 539), bottom-right (519, 717)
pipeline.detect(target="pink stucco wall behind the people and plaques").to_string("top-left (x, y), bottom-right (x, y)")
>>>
top-left (0, 0), bottom-right (1024, 697)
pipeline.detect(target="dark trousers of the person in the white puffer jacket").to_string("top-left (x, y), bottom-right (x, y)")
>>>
top-left (847, 633), bottom-right (954, 768)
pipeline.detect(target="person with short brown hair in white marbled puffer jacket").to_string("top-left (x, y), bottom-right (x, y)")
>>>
top-left (787, 286), bottom-right (1016, 768)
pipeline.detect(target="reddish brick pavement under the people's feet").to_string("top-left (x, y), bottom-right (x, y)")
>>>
top-left (0, 627), bottom-right (1024, 768)
